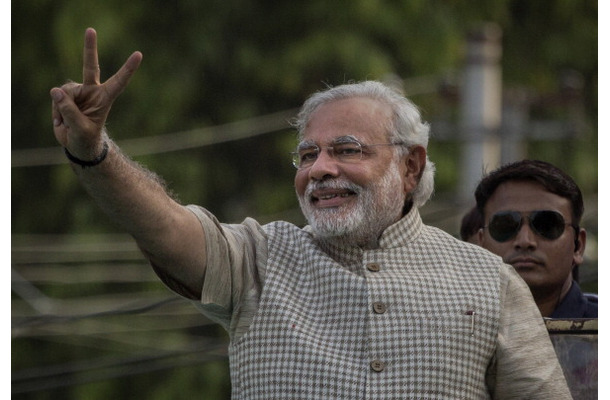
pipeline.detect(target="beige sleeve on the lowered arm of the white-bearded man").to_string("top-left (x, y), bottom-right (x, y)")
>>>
top-left (488, 265), bottom-right (572, 400)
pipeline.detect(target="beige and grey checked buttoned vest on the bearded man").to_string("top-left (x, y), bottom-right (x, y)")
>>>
top-left (229, 213), bottom-right (500, 400)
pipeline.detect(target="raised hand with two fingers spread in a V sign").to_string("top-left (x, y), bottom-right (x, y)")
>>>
top-left (51, 28), bottom-right (142, 160)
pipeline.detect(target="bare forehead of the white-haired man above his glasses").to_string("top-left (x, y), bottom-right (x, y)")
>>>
top-left (303, 97), bottom-right (392, 144)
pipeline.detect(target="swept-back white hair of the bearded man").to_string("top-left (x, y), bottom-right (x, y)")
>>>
top-left (293, 81), bottom-right (435, 207)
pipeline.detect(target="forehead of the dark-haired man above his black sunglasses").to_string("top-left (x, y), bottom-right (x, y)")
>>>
top-left (485, 181), bottom-right (571, 216)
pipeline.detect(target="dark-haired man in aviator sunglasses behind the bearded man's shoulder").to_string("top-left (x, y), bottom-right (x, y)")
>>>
top-left (475, 160), bottom-right (597, 318)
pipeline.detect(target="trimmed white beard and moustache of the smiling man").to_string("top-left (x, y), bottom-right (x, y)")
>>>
top-left (298, 162), bottom-right (405, 247)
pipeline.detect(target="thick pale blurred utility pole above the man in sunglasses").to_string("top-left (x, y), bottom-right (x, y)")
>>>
top-left (458, 24), bottom-right (502, 203)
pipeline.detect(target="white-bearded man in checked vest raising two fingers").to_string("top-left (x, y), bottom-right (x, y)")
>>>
top-left (51, 29), bottom-right (571, 399)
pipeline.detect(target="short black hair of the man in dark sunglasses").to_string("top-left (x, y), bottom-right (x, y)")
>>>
top-left (474, 160), bottom-right (585, 225)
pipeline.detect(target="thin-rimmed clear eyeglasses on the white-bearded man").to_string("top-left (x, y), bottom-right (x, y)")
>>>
top-left (290, 140), bottom-right (402, 169)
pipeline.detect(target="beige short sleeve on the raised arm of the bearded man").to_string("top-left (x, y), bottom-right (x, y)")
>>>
top-left (188, 205), bottom-right (267, 337)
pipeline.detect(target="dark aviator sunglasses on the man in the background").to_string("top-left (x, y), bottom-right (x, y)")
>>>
top-left (485, 210), bottom-right (578, 243)
